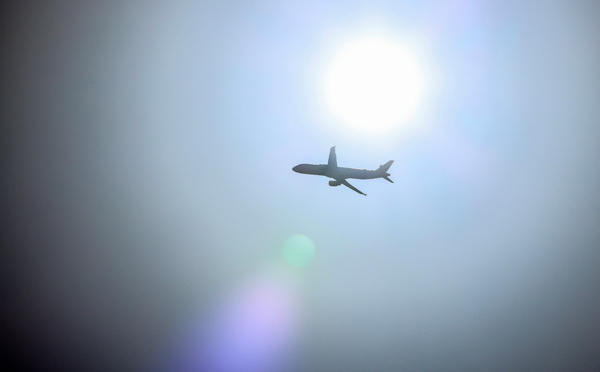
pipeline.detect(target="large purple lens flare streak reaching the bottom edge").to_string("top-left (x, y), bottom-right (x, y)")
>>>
top-left (160, 277), bottom-right (298, 372)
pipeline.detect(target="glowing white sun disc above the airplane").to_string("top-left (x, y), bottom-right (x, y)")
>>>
top-left (325, 38), bottom-right (423, 132)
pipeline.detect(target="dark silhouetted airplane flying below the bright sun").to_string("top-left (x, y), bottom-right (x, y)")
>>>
top-left (292, 146), bottom-right (394, 196)
